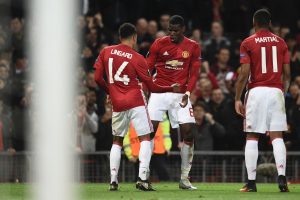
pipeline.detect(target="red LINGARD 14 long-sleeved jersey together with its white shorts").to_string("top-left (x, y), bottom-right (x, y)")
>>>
top-left (94, 44), bottom-right (166, 137)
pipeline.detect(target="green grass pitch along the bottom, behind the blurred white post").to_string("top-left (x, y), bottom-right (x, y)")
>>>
top-left (0, 183), bottom-right (300, 200)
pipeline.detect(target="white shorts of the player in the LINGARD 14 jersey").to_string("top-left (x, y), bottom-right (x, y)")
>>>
top-left (112, 106), bottom-right (153, 137)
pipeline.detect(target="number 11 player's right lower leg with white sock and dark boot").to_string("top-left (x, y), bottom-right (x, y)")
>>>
top-left (270, 131), bottom-right (289, 192)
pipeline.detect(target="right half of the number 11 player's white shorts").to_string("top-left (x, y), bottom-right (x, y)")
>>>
top-left (268, 88), bottom-right (287, 131)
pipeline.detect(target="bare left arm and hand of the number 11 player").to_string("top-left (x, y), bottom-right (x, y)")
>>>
top-left (235, 64), bottom-right (250, 117)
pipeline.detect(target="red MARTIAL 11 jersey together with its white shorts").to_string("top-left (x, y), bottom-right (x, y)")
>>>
top-left (240, 30), bottom-right (290, 133)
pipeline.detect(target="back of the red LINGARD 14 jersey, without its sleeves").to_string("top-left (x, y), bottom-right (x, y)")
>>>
top-left (100, 44), bottom-right (145, 112)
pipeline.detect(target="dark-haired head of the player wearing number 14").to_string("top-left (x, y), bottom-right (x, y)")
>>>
top-left (119, 23), bottom-right (137, 46)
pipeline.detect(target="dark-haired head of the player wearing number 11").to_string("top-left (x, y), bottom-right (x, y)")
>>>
top-left (253, 9), bottom-right (271, 28)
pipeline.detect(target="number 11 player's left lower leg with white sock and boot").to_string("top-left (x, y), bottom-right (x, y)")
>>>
top-left (240, 133), bottom-right (260, 192)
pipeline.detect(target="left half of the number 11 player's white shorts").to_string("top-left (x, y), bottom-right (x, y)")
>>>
top-left (244, 87), bottom-right (268, 133)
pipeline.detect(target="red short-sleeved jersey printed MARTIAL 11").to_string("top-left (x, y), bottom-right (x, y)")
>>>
top-left (240, 30), bottom-right (290, 89)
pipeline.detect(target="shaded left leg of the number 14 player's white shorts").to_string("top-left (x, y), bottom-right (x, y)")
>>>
top-left (111, 110), bottom-right (130, 137)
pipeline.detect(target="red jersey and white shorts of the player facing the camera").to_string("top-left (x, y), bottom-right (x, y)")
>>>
top-left (147, 36), bottom-right (200, 128)
